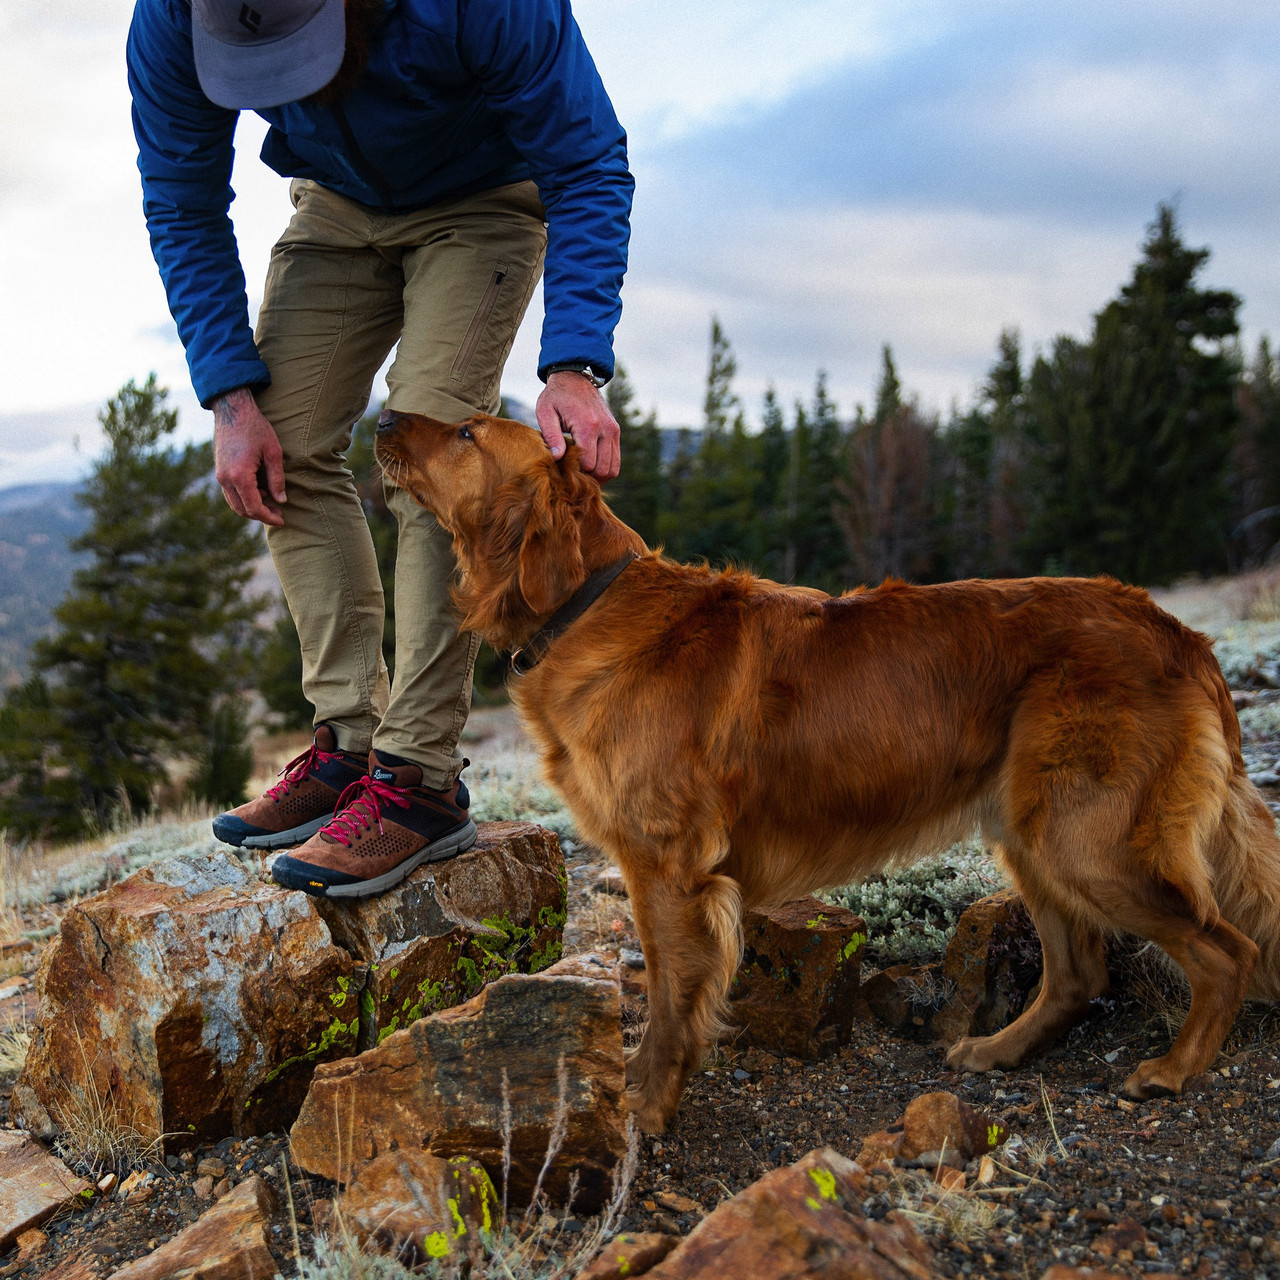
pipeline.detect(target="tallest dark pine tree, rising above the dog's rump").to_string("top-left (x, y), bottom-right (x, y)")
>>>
top-left (1028, 205), bottom-right (1240, 585)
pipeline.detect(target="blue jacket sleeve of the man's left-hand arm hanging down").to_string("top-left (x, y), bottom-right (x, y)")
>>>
top-left (127, 0), bottom-right (271, 408)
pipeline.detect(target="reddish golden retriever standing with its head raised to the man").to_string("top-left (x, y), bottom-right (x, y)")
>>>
top-left (378, 413), bottom-right (1280, 1133)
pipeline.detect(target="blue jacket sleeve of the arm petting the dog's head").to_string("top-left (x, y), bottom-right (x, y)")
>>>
top-left (460, 0), bottom-right (635, 374)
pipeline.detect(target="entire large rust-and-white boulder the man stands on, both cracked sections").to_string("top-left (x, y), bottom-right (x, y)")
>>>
top-left (13, 823), bottom-right (564, 1146)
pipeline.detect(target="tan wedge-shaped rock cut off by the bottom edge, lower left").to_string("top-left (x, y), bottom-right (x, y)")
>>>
top-left (111, 1175), bottom-right (278, 1280)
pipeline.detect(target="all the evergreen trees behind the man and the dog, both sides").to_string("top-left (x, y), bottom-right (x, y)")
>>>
top-left (0, 205), bottom-right (1280, 837)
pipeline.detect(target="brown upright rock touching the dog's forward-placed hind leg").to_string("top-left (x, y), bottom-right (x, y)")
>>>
top-left (932, 888), bottom-right (1042, 1044)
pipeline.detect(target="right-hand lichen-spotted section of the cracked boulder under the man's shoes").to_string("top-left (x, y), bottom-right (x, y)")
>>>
top-left (316, 822), bottom-right (567, 1048)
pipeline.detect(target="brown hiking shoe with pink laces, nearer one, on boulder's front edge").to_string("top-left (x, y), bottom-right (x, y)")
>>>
top-left (271, 751), bottom-right (476, 897)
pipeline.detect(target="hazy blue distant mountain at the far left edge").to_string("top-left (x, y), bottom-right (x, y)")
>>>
top-left (0, 484), bottom-right (90, 686)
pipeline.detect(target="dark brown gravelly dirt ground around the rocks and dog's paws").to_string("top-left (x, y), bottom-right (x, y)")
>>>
top-left (0, 614), bottom-right (1280, 1280)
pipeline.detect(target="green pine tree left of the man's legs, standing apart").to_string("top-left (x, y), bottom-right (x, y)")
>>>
top-left (3, 375), bottom-right (261, 831)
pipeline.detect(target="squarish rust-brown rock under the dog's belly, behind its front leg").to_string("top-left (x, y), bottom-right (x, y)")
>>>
top-left (728, 897), bottom-right (867, 1059)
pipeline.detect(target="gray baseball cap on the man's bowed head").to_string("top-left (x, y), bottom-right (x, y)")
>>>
top-left (191, 0), bottom-right (347, 109)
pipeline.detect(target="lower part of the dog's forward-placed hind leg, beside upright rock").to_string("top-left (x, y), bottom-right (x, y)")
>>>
top-left (947, 896), bottom-right (1107, 1071)
